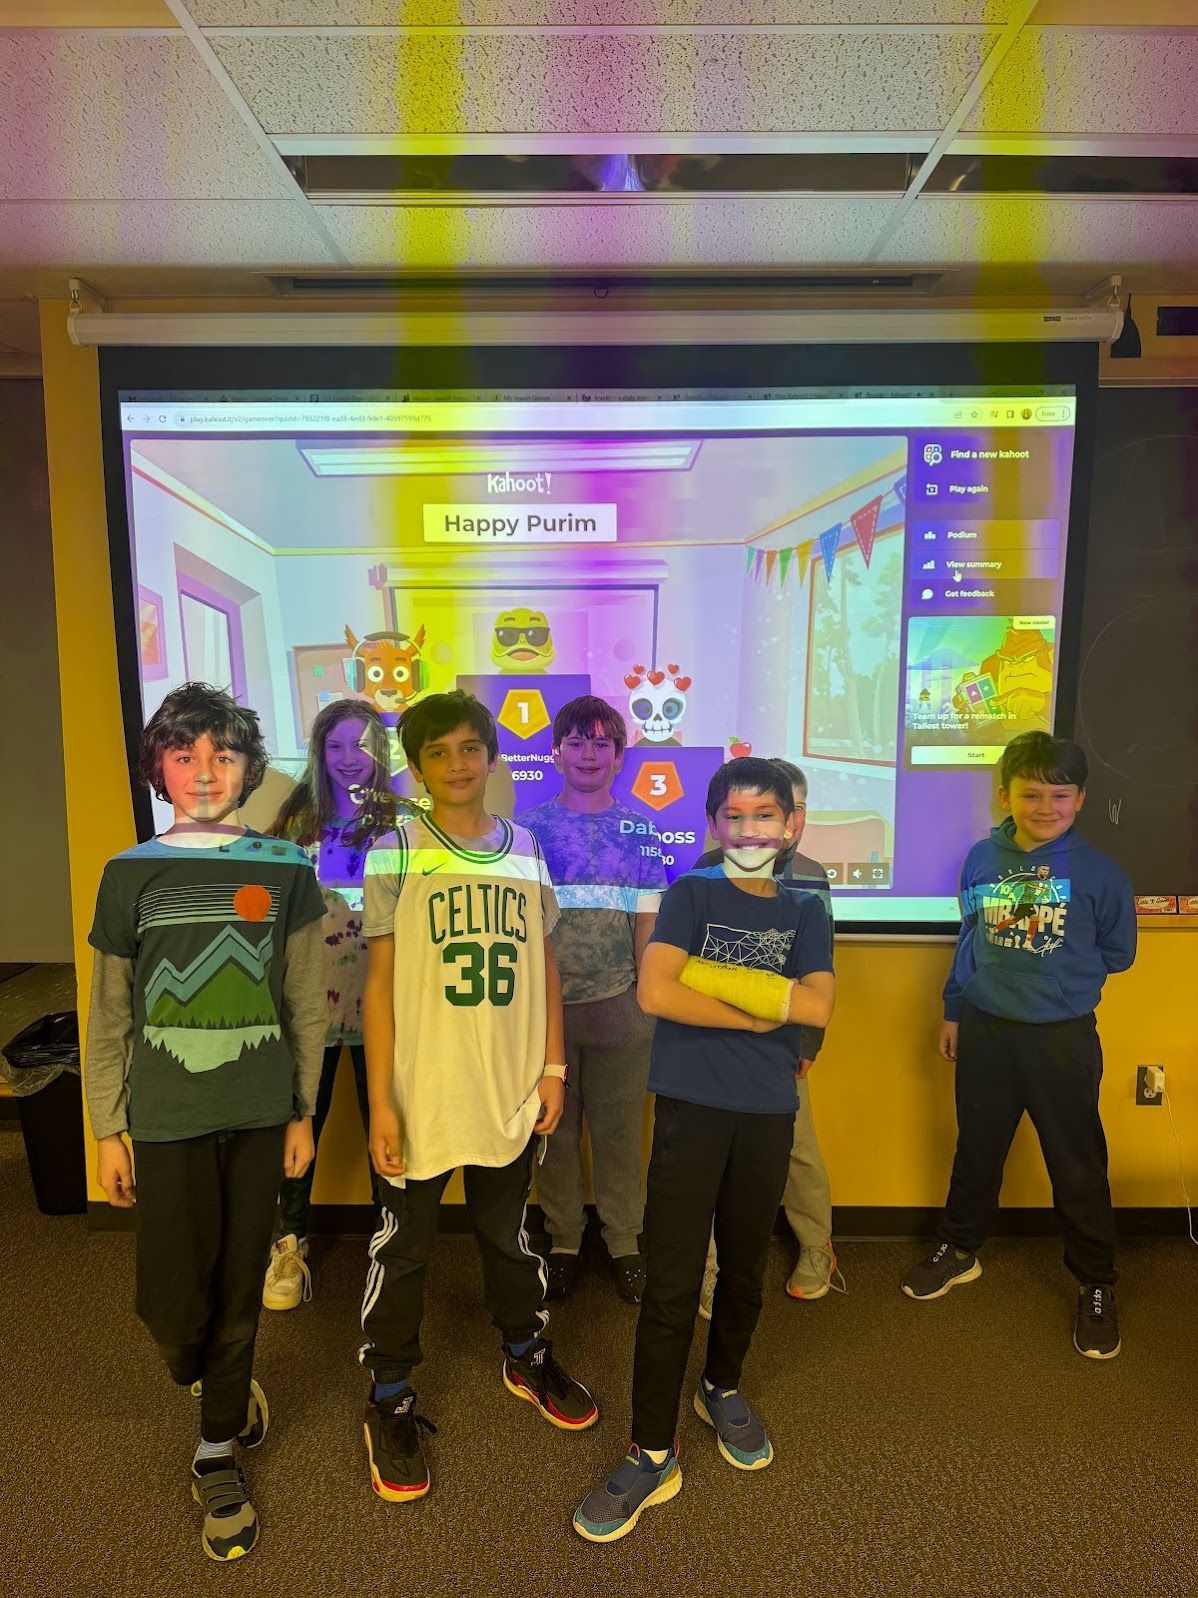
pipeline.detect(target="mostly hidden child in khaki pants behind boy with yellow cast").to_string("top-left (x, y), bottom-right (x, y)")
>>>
top-left (696, 757), bottom-right (837, 1320)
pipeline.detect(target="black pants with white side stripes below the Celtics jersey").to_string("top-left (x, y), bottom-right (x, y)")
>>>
top-left (358, 1136), bottom-right (548, 1382)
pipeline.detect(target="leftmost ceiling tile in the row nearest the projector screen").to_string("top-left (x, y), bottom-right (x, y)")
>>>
top-left (0, 200), bottom-right (338, 276)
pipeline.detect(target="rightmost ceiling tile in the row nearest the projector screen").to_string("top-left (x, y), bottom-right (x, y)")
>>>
top-left (883, 195), bottom-right (1198, 266)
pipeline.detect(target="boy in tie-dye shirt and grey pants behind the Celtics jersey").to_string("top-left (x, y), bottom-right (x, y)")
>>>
top-left (521, 694), bottom-right (666, 1304)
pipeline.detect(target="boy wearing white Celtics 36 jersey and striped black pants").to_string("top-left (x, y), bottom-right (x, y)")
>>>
top-left (359, 692), bottom-right (599, 1504)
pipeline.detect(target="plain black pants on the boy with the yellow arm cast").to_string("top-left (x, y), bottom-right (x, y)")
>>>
top-left (633, 1095), bottom-right (794, 1448)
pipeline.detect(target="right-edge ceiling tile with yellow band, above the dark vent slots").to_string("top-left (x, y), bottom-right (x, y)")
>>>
top-left (966, 29), bottom-right (1198, 134)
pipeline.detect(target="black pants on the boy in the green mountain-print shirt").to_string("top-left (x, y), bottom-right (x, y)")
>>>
top-left (134, 1127), bottom-right (284, 1443)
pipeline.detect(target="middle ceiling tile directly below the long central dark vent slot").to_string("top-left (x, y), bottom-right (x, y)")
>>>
top-left (321, 197), bottom-right (879, 272)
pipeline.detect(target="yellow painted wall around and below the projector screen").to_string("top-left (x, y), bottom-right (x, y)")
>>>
top-left (42, 302), bottom-right (1198, 1205)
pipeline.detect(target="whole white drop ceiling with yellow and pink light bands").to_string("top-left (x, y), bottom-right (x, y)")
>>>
top-left (0, 0), bottom-right (1198, 365)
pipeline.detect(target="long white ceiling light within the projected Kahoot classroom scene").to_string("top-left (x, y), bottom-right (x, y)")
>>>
top-left (296, 439), bottom-right (698, 478)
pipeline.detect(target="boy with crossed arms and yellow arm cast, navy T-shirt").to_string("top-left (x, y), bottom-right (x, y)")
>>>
top-left (573, 757), bottom-right (835, 1542)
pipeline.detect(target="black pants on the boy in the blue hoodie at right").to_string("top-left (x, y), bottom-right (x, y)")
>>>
top-left (941, 1004), bottom-right (1117, 1283)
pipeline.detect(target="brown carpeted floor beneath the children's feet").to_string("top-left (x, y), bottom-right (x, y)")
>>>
top-left (0, 1130), bottom-right (1198, 1598)
